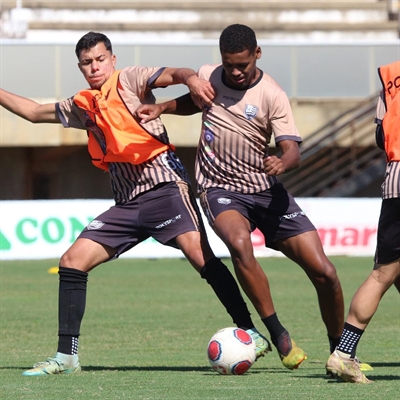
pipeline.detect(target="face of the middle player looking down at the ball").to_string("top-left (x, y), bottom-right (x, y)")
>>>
top-left (221, 47), bottom-right (261, 89)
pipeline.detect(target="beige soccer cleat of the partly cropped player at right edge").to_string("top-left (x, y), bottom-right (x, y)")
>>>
top-left (326, 351), bottom-right (371, 383)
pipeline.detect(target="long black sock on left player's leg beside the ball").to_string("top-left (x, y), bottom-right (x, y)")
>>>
top-left (200, 257), bottom-right (254, 330)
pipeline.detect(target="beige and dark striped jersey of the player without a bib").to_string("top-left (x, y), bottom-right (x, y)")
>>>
top-left (196, 65), bottom-right (302, 193)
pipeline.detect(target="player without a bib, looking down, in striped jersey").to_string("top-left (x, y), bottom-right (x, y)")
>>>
top-left (138, 24), bottom-right (350, 369)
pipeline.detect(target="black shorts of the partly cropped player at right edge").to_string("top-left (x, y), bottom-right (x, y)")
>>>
top-left (375, 197), bottom-right (400, 264)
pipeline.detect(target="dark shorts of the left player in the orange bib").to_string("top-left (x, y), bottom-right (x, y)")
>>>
top-left (78, 182), bottom-right (205, 257)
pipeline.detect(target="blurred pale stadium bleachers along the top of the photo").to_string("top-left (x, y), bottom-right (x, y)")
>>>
top-left (0, 0), bottom-right (399, 41)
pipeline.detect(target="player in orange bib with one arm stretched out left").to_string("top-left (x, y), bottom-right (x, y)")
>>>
top-left (0, 32), bottom-right (270, 376)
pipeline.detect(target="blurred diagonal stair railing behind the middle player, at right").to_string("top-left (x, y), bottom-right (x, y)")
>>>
top-left (280, 94), bottom-right (385, 197)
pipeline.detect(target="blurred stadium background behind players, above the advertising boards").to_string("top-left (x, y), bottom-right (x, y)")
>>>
top-left (0, 0), bottom-right (400, 200)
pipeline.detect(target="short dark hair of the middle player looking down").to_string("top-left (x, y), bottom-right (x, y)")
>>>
top-left (219, 24), bottom-right (257, 54)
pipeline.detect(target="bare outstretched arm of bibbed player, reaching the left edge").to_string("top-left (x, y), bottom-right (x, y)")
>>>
top-left (0, 89), bottom-right (60, 123)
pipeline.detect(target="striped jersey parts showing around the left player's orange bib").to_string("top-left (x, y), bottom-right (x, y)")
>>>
top-left (56, 67), bottom-right (189, 203)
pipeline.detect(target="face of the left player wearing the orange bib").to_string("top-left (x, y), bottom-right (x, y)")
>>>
top-left (78, 42), bottom-right (116, 89)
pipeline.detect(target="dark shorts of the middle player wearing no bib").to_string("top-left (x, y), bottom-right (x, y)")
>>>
top-left (200, 183), bottom-right (316, 250)
